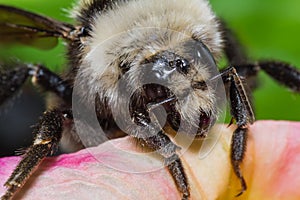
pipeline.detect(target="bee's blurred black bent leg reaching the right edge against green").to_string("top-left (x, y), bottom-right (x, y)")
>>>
top-left (219, 19), bottom-right (300, 92)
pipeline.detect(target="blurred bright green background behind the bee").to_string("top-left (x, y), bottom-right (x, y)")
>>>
top-left (0, 0), bottom-right (300, 121)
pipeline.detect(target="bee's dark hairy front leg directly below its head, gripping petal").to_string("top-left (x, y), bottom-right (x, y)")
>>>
top-left (128, 113), bottom-right (190, 200)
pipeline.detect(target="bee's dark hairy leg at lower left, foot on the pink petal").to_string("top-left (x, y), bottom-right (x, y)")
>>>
top-left (1, 109), bottom-right (72, 200)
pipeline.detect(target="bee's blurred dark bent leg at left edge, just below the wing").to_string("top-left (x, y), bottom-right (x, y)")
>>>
top-left (0, 63), bottom-right (72, 105)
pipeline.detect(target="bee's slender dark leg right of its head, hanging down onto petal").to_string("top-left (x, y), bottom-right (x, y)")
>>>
top-left (222, 67), bottom-right (254, 196)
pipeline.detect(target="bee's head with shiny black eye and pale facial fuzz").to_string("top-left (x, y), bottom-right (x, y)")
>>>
top-left (138, 40), bottom-right (223, 137)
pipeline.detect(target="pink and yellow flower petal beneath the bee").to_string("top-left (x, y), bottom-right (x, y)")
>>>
top-left (0, 121), bottom-right (300, 200)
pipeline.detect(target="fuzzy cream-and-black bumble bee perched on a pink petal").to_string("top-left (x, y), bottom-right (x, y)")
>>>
top-left (0, 0), bottom-right (300, 199)
